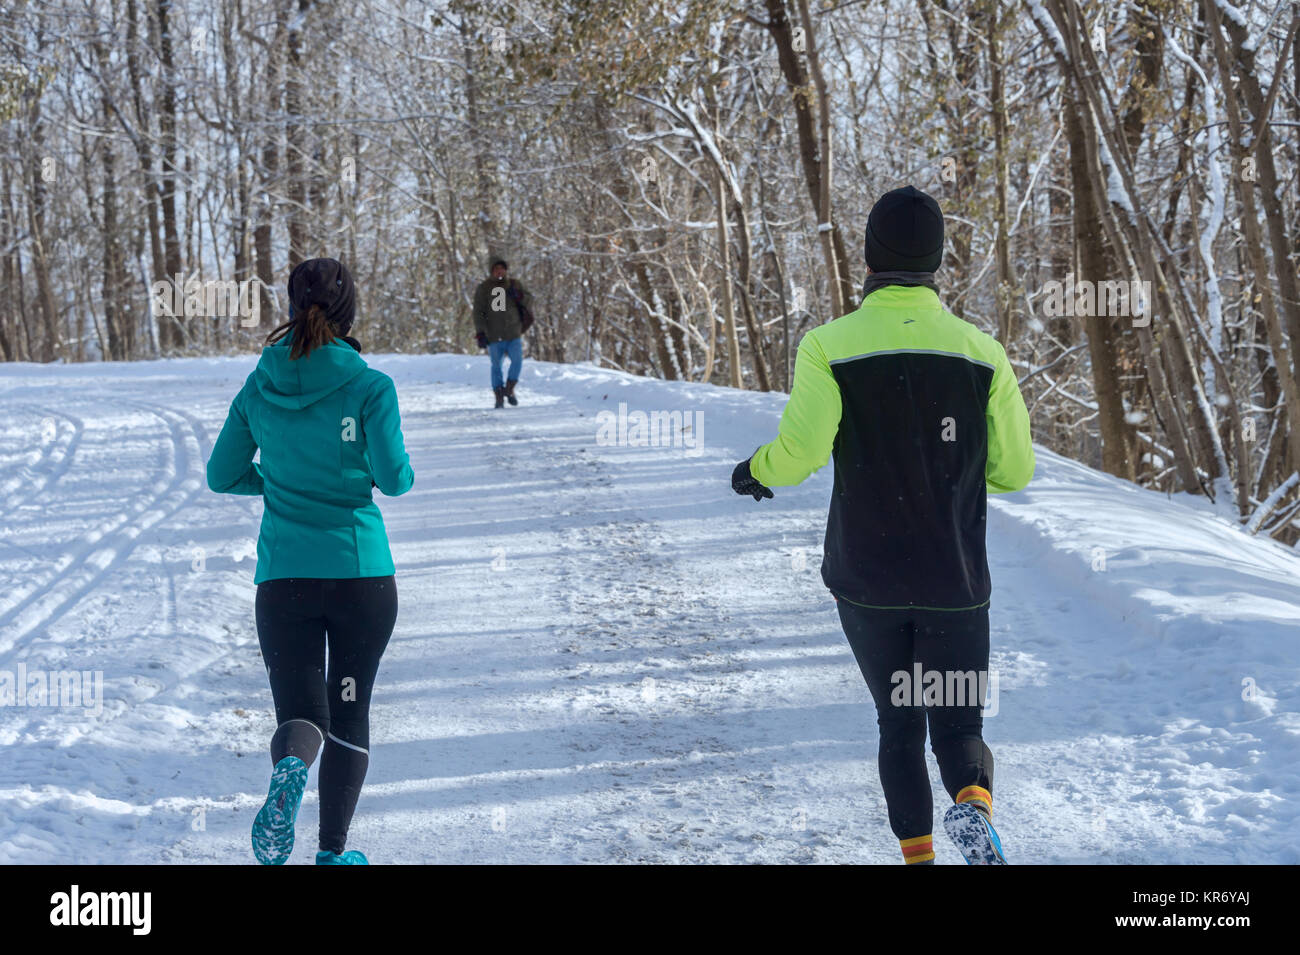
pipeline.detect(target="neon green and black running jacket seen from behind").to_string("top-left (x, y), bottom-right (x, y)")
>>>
top-left (750, 286), bottom-right (1034, 609)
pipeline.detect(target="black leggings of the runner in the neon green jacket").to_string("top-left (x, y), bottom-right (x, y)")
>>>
top-left (837, 600), bottom-right (993, 839)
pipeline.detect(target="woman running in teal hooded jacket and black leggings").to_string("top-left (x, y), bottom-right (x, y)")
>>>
top-left (208, 259), bottom-right (415, 865)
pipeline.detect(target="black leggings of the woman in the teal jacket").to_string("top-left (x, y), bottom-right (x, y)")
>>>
top-left (257, 577), bottom-right (398, 852)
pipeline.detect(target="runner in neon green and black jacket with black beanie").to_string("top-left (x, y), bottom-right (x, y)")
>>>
top-left (732, 186), bottom-right (1034, 865)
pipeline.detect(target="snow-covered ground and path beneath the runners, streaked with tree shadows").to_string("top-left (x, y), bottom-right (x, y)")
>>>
top-left (0, 356), bottom-right (1300, 864)
